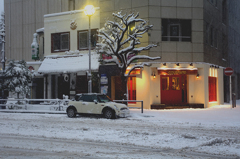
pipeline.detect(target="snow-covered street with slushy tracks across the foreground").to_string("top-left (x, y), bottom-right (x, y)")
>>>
top-left (0, 101), bottom-right (240, 158)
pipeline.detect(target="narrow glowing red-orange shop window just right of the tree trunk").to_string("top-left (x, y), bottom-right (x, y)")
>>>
top-left (127, 77), bottom-right (136, 104)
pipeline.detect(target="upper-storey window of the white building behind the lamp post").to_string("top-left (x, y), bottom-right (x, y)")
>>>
top-left (78, 29), bottom-right (97, 50)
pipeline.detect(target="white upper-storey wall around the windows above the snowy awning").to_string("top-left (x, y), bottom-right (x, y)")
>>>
top-left (44, 10), bottom-right (100, 56)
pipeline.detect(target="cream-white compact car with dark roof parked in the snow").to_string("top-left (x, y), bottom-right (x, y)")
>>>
top-left (66, 93), bottom-right (130, 119)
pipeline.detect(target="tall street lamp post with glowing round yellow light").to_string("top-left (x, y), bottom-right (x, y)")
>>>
top-left (84, 5), bottom-right (95, 93)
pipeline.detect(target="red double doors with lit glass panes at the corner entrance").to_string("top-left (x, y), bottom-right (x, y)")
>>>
top-left (161, 75), bottom-right (187, 105)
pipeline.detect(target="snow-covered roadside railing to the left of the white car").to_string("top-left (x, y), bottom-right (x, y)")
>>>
top-left (0, 98), bottom-right (69, 111)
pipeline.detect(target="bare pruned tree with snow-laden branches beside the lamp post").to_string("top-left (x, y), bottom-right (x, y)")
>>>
top-left (97, 12), bottom-right (160, 99)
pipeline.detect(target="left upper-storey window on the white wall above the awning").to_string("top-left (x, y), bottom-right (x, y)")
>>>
top-left (51, 32), bottom-right (70, 52)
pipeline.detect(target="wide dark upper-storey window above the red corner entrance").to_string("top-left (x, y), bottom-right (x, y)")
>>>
top-left (162, 19), bottom-right (192, 41)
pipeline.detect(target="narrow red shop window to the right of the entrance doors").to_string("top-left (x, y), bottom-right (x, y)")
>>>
top-left (208, 77), bottom-right (217, 102)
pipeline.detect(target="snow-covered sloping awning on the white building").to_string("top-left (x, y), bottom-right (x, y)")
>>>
top-left (38, 53), bottom-right (99, 74)
